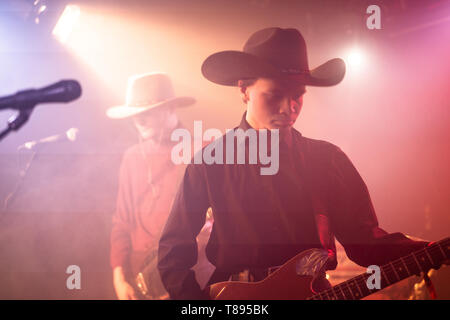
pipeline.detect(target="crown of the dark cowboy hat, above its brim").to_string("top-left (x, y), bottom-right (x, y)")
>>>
top-left (243, 28), bottom-right (309, 73)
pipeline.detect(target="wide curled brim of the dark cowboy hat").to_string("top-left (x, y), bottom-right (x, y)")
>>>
top-left (202, 51), bottom-right (345, 87)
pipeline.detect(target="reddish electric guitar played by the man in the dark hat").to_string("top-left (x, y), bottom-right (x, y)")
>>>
top-left (207, 238), bottom-right (450, 300)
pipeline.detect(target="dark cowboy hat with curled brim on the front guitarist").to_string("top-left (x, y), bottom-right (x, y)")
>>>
top-left (202, 28), bottom-right (345, 87)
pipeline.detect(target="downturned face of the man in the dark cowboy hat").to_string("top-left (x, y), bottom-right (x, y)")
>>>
top-left (239, 77), bottom-right (306, 130)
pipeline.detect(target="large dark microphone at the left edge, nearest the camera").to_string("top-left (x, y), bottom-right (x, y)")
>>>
top-left (0, 80), bottom-right (81, 110)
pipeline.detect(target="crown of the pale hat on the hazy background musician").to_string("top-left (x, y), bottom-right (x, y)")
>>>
top-left (126, 73), bottom-right (175, 107)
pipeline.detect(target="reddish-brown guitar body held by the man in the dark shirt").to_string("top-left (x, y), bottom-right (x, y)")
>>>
top-left (209, 249), bottom-right (328, 300)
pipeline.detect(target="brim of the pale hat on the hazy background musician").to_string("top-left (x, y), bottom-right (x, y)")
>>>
top-left (106, 97), bottom-right (196, 119)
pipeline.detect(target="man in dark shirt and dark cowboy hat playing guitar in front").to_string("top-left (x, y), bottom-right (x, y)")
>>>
top-left (158, 28), bottom-right (426, 299)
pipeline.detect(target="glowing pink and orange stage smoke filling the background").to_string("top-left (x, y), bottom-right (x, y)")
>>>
top-left (0, 1), bottom-right (450, 299)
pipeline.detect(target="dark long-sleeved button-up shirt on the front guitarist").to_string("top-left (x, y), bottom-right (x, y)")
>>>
top-left (158, 114), bottom-right (425, 299)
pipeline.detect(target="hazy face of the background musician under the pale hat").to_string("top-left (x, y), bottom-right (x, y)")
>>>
top-left (133, 107), bottom-right (178, 140)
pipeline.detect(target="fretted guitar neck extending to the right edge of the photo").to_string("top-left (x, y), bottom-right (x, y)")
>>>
top-left (309, 238), bottom-right (450, 300)
